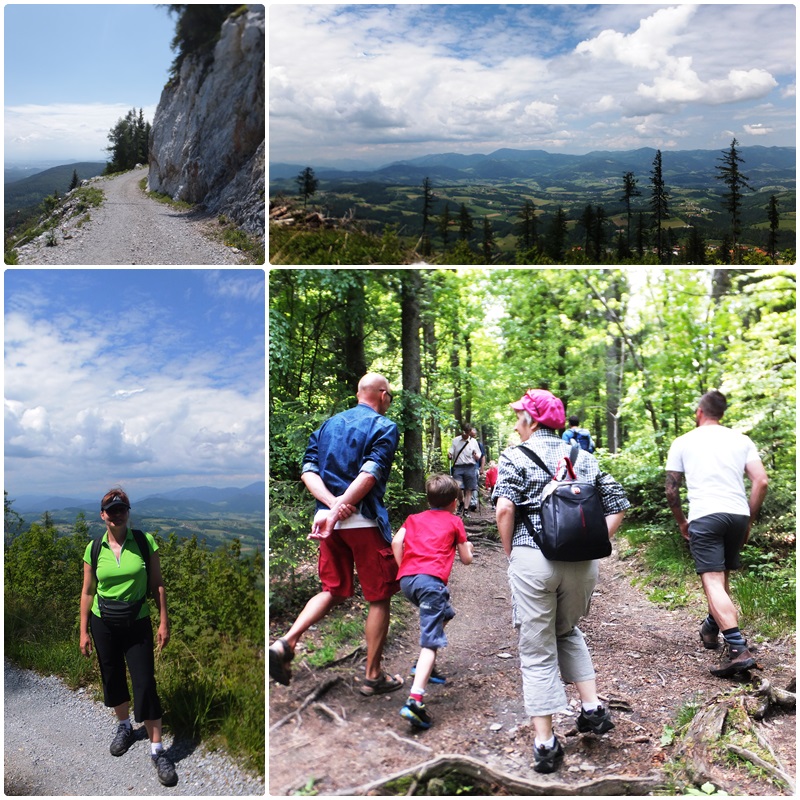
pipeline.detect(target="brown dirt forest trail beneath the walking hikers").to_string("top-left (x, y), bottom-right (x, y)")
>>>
top-left (268, 507), bottom-right (796, 796)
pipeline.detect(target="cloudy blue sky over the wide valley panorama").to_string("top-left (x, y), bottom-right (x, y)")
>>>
top-left (269, 3), bottom-right (796, 165)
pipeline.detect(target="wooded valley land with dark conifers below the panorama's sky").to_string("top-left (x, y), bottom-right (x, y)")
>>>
top-left (270, 139), bottom-right (796, 265)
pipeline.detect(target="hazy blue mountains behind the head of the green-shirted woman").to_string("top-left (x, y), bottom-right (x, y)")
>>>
top-left (9, 481), bottom-right (266, 520)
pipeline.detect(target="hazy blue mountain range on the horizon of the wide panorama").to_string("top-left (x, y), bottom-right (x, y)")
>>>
top-left (269, 146), bottom-right (797, 189)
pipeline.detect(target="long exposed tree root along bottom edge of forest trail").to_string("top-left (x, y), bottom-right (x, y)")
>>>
top-left (336, 754), bottom-right (663, 797)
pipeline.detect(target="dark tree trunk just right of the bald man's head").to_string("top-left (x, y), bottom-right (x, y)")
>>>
top-left (400, 269), bottom-right (425, 504)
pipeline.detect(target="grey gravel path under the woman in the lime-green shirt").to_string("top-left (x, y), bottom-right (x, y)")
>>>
top-left (4, 661), bottom-right (264, 797)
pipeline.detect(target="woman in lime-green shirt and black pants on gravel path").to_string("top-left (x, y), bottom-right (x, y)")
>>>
top-left (80, 489), bottom-right (178, 786)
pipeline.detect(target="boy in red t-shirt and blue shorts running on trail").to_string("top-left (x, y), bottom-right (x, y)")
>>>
top-left (392, 474), bottom-right (472, 729)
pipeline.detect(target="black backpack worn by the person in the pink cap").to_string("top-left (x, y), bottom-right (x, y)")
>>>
top-left (517, 442), bottom-right (611, 561)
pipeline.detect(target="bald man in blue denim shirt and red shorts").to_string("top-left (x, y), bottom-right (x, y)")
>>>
top-left (269, 372), bottom-right (403, 696)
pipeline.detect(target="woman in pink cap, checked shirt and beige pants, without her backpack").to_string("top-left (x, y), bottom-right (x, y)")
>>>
top-left (493, 389), bottom-right (630, 773)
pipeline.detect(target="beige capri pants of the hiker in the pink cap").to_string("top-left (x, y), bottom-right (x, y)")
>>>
top-left (508, 547), bottom-right (598, 717)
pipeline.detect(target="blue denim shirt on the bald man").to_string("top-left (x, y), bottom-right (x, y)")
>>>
top-left (302, 403), bottom-right (399, 542)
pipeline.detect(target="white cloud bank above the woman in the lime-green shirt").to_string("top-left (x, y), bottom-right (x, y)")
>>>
top-left (4, 310), bottom-right (265, 495)
